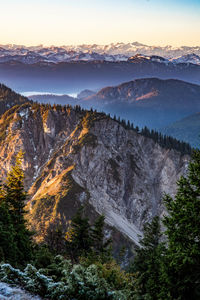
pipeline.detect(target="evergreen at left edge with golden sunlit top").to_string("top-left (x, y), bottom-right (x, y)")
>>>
top-left (0, 151), bottom-right (32, 266)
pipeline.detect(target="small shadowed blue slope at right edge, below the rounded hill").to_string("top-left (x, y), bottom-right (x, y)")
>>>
top-left (161, 113), bottom-right (200, 148)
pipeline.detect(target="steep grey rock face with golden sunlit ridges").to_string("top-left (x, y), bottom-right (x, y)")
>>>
top-left (0, 103), bottom-right (189, 244)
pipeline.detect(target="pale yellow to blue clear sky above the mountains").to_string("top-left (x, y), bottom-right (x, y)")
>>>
top-left (0, 0), bottom-right (200, 47)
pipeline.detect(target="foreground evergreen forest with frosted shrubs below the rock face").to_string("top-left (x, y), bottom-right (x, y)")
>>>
top-left (0, 151), bottom-right (200, 300)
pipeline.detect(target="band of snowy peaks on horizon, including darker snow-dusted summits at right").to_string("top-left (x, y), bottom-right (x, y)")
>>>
top-left (0, 42), bottom-right (200, 64)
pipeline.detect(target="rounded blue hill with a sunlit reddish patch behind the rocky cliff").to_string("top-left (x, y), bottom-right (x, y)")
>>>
top-left (30, 78), bottom-right (200, 130)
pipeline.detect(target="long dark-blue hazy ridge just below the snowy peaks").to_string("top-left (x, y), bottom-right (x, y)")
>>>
top-left (0, 55), bottom-right (200, 94)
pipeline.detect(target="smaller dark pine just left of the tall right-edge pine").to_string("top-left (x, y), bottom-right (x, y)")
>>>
top-left (131, 216), bottom-right (164, 300)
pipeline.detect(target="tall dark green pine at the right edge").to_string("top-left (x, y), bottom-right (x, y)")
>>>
top-left (164, 151), bottom-right (200, 300)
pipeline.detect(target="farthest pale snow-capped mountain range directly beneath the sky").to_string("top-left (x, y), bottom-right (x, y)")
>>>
top-left (0, 42), bottom-right (200, 62)
